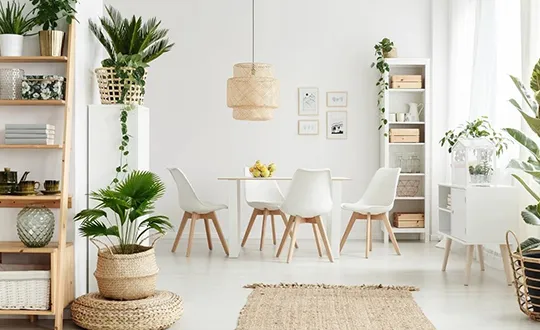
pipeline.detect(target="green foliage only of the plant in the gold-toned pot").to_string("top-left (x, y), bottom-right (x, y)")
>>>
top-left (32, 0), bottom-right (78, 30)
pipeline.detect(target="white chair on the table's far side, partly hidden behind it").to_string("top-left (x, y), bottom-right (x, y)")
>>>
top-left (242, 167), bottom-right (298, 251)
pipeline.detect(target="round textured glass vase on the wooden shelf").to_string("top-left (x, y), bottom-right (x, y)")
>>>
top-left (17, 205), bottom-right (55, 247)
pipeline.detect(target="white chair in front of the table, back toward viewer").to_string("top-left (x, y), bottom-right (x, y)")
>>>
top-left (276, 169), bottom-right (334, 263)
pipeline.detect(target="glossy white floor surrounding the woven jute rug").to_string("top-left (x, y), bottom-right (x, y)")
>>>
top-left (4, 240), bottom-right (540, 330)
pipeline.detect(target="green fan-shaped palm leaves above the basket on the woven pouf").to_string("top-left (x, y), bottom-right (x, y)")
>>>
top-left (75, 171), bottom-right (172, 254)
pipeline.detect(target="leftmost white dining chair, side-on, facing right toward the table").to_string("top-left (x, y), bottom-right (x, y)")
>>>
top-left (169, 168), bottom-right (229, 257)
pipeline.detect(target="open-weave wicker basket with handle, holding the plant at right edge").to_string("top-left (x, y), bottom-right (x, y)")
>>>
top-left (506, 231), bottom-right (540, 321)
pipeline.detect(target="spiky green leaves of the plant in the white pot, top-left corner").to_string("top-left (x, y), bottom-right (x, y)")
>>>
top-left (0, 0), bottom-right (36, 35)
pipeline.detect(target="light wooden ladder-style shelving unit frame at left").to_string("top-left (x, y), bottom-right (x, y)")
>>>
top-left (0, 24), bottom-right (76, 330)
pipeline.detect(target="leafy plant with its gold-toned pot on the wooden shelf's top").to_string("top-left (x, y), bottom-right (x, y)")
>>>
top-left (32, 0), bottom-right (78, 56)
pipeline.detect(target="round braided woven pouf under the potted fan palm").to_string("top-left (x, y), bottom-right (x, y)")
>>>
top-left (71, 291), bottom-right (184, 330)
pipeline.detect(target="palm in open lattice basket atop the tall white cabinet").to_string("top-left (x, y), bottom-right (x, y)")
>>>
top-left (89, 6), bottom-right (174, 104)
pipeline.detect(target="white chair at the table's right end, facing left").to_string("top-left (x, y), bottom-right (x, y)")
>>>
top-left (339, 168), bottom-right (401, 258)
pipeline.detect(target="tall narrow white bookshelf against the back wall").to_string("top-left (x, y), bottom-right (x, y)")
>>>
top-left (380, 58), bottom-right (431, 243)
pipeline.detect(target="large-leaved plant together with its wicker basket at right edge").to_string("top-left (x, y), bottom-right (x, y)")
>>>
top-left (504, 60), bottom-right (540, 320)
